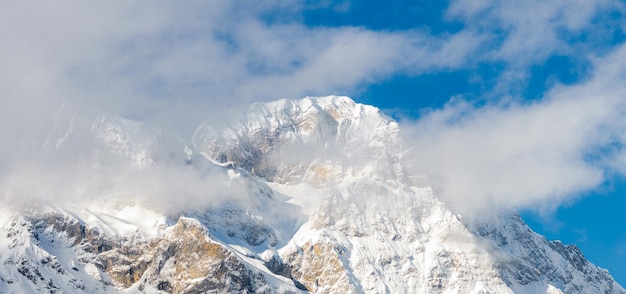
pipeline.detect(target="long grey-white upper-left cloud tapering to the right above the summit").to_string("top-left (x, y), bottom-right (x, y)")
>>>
top-left (0, 1), bottom-right (478, 136)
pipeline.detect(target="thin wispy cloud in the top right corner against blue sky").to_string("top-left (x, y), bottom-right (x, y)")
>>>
top-left (446, 0), bottom-right (626, 96)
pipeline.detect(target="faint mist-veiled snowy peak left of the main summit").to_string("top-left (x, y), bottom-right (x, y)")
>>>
top-left (20, 101), bottom-right (183, 167)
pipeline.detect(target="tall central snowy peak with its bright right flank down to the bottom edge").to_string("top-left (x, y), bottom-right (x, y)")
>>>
top-left (194, 96), bottom-right (622, 293)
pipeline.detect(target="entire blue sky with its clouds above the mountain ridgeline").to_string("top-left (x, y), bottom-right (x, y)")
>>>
top-left (0, 0), bottom-right (626, 285)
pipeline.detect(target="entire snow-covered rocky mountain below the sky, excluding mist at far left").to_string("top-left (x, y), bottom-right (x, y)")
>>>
top-left (0, 96), bottom-right (626, 293)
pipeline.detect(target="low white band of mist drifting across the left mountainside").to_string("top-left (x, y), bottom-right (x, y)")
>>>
top-left (0, 157), bottom-right (249, 216)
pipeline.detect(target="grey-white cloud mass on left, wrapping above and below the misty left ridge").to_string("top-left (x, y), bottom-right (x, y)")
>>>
top-left (0, 1), bottom-right (480, 209)
